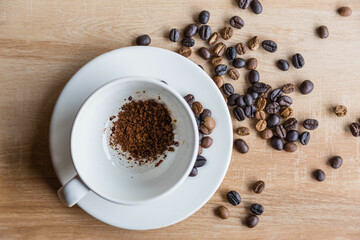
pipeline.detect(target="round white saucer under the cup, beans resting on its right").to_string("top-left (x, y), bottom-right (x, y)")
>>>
top-left (50, 47), bottom-right (233, 230)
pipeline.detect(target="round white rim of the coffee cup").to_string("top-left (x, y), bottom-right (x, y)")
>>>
top-left (70, 76), bottom-right (199, 205)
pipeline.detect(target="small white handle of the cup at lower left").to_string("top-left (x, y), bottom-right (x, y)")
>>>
top-left (58, 175), bottom-right (90, 207)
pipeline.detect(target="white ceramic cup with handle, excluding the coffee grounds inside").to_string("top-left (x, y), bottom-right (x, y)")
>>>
top-left (58, 77), bottom-right (199, 207)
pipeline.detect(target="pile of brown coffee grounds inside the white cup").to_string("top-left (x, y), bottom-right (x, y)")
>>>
top-left (110, 99), bottom-right (175, 162)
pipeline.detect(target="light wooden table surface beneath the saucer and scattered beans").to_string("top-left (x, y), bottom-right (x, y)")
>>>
top-left (0, 0), bottom-right (360, 239)
